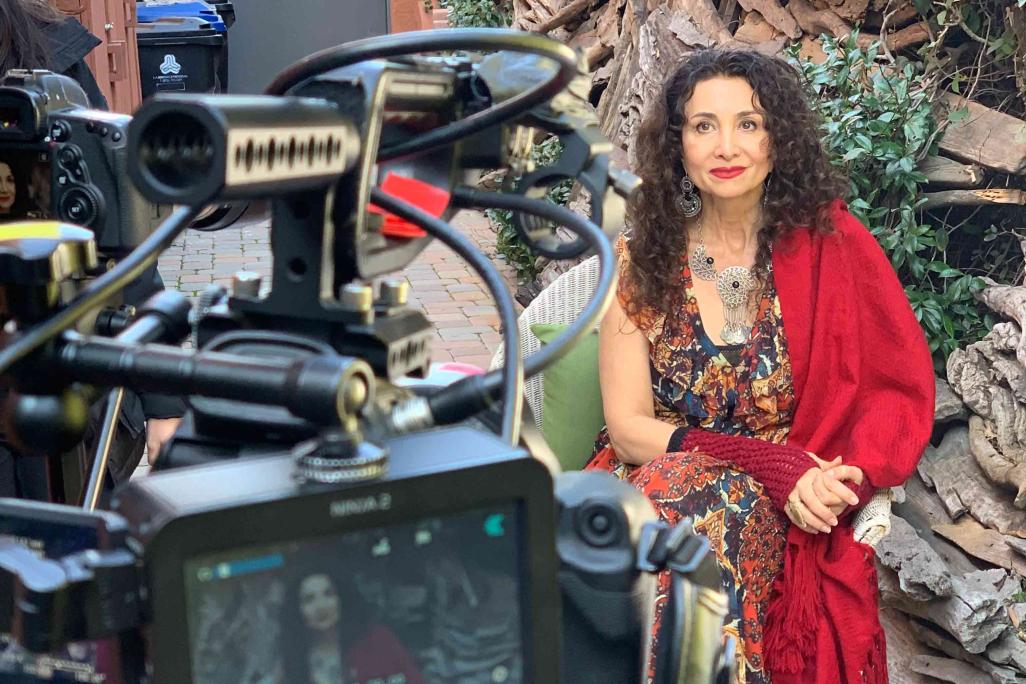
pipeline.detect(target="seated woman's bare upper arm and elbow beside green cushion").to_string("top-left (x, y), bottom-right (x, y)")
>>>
top-left (598, 298), bottom-right (674, 466)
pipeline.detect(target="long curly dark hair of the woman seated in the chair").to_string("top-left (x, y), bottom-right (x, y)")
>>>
top-left (625, 48), bottom-right (849, 318)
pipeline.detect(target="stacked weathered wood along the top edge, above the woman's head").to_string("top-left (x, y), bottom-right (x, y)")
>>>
top-left (513, 0), bottom-right (943, 150)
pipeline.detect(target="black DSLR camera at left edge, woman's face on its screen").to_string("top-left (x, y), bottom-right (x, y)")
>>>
top-left (0, 70), bottom-right (169, 256)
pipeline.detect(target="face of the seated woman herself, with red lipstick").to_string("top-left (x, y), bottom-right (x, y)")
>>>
top-left (681, 76), bottom-right (773, 201)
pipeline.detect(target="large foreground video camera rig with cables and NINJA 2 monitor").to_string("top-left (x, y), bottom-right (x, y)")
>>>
top-left (0, 30), bottom-right (734, 684)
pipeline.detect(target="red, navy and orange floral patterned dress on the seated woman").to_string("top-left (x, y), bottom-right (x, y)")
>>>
top-left (587, 233), bottom-right (794, 684)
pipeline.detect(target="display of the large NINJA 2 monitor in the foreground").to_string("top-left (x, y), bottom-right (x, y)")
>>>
top-left (179, 504), bottom-right (526, 684)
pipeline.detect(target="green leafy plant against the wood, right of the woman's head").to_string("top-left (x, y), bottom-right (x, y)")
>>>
top-left (791, 34), bottom-right (990, 369)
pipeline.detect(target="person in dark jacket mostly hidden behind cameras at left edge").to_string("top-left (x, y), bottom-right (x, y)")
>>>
top-left (0, 0), bottom-right (185, 499)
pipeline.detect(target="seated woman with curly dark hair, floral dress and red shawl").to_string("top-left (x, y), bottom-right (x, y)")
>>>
top-left (588, 50), bottom-right (934, 684)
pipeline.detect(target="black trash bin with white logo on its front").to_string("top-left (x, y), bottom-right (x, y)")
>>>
top-left (136, 16), bottom-right (228, 97)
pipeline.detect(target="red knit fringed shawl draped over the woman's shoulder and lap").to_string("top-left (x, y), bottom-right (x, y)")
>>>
top-left (765, 202), bottom-right (935, 684)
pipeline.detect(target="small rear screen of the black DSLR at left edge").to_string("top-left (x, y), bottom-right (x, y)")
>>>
top-left (0, 148), bottom-right (52, 224)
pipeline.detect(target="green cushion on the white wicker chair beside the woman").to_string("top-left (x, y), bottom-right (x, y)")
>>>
top-left (530, 323), bottom-right (605, 471)
